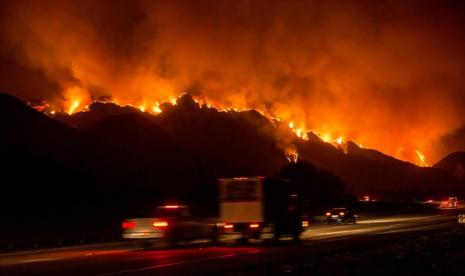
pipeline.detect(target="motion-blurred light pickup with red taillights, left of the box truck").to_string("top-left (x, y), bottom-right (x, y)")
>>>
top-left (122, 205), bottom-right (218, 245)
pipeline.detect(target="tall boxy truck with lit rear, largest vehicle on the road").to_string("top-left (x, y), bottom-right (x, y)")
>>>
top-left (218, 177), bottom-right (309, 241)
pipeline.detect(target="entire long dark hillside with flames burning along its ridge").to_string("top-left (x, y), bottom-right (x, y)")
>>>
top-left (0, 94), bottom-right (463, 199)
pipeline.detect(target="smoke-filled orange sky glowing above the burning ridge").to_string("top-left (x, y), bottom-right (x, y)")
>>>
top-left (0, 0), bottom-right (465, 164)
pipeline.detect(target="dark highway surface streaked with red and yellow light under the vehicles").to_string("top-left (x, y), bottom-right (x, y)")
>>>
top-left (0, 215), bottom-right (457, 275)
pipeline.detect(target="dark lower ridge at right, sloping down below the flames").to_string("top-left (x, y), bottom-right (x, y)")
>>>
top-left (299, 141), bottom-right (464, 199)
